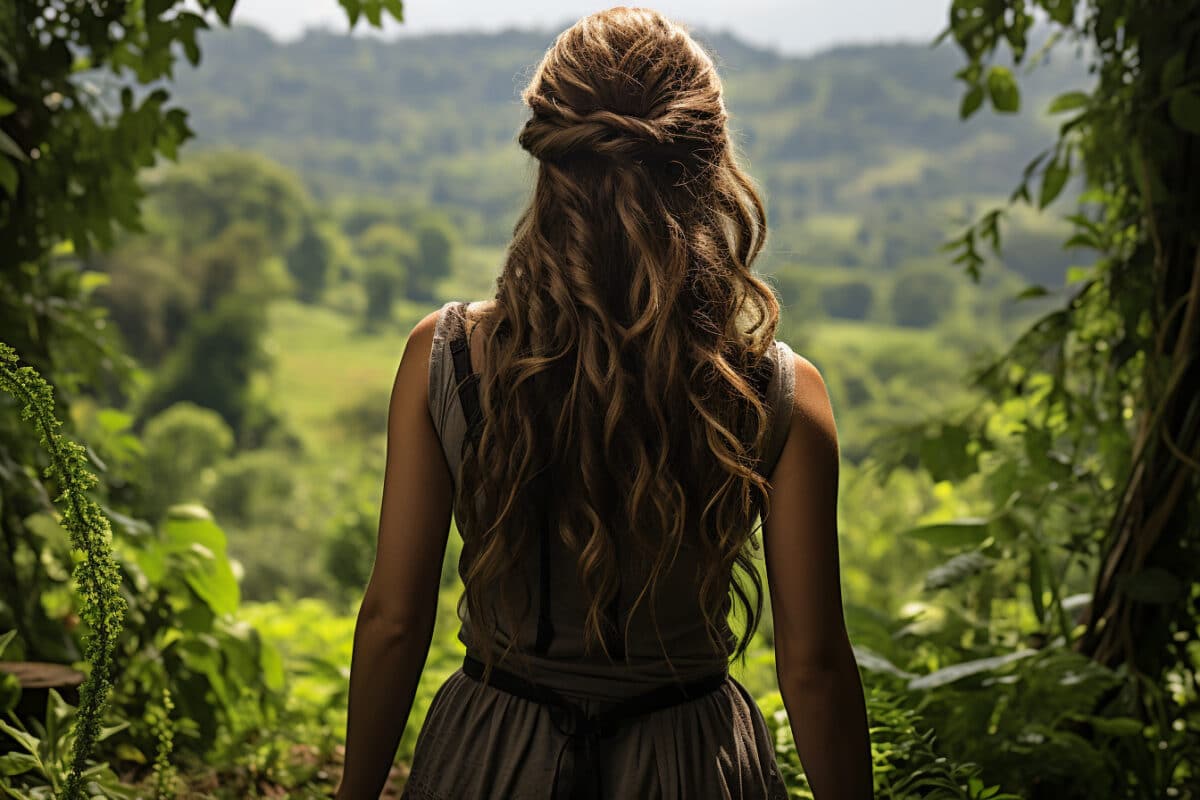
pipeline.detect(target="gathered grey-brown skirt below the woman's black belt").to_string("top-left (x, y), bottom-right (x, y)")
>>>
top-left (401, 669), bottom-right (787, 800)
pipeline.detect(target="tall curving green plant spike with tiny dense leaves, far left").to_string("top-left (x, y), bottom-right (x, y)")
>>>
top-left (0, 342), bottom-right (126, 800)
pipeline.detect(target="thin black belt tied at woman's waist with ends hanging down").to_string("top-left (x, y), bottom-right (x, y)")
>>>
top-left (462, 655), bottom-right (728, 800)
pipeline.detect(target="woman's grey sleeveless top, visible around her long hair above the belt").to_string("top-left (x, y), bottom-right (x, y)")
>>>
top-left (428, 301), bottom-right (794, 702)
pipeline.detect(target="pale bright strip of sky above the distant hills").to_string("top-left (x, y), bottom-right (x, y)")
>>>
top-left (225, 0), bottom-right (949, 55)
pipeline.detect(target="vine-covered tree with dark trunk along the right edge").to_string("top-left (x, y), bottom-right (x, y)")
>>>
top-left (926, 0), bottom-right (1200, 796)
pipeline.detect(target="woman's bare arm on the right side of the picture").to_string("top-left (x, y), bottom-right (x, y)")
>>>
top-left (763, 355), bottom-right (872, 800)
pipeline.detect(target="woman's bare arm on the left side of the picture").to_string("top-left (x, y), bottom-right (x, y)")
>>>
top-left (336, 312), bottom-right (454, 800)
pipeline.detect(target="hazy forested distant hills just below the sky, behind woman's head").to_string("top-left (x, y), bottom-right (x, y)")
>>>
top-left (175, 26), bottom-right (1086, 253)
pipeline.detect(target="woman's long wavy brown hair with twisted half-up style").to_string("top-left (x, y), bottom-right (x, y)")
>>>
top-left (458, 7), bottom-right (779, 667)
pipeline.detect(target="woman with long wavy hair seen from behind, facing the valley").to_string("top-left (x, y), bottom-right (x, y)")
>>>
top-left (337, 8), bottom-right (871, 800)
